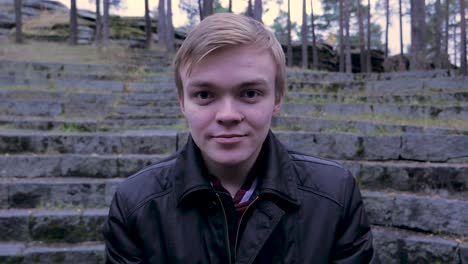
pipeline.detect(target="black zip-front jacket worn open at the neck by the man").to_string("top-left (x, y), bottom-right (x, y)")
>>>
top-left (103, 132), bottom-right (378, 263)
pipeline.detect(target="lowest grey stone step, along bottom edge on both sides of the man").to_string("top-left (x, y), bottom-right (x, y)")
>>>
top-left (0, 229), bottom-right (468, 264)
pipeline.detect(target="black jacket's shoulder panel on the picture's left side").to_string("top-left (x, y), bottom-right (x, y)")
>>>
top-left (116, 153), bottom-right (178, 217)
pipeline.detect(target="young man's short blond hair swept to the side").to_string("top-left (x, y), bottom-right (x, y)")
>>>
top-left (174, 13), bottom-right (286, 100)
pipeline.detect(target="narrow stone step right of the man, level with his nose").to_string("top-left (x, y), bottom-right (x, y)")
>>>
top-left (281, 103), bottom-right (468, 120)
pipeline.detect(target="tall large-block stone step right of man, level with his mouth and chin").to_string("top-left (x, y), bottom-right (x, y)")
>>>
top-left (274, 131), bottom-right (468, 162)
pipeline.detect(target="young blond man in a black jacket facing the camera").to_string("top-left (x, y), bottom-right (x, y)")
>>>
top-left (104, 14), bottom-right (376, 263)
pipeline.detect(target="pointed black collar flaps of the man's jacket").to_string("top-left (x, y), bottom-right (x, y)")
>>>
top-left (175, 131), bottom-right (299, 205)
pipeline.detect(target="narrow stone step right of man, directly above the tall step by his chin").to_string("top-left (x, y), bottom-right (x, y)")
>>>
top-left (272, 116), bottom-right (468, 135)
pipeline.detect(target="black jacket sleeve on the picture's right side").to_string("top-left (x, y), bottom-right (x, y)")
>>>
top-left (333, 172), bottom-right (380, 264)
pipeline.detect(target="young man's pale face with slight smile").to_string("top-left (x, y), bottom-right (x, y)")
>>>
top-left (179, 46), bottom-right (280, 167)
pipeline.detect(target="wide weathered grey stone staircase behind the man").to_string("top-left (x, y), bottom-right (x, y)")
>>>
top-left (0, 58), bottom-right (468, 263)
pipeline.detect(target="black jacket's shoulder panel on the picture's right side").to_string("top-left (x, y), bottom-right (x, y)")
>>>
top-left (288, 151), bottom-right (355, 207)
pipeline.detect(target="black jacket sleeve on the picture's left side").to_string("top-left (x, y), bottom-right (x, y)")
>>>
top-left (102, 192), bottom-right (142, 264)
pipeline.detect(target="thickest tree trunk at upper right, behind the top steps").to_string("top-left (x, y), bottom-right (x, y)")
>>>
top-left (410, 0), bottom-right (426, 70)
